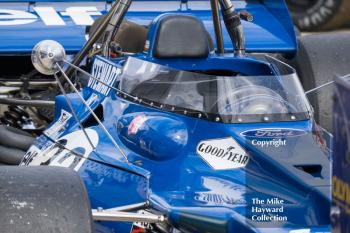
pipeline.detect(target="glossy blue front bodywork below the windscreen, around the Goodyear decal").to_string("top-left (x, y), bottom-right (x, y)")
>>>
top-left (24, 55), bottom-right (330, 232)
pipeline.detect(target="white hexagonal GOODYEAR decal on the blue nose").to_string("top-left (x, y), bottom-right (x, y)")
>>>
top-left (197, 137), bottom-right (249, 170)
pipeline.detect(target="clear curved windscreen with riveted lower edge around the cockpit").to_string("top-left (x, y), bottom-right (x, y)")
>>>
top-left (119, 57), bottom-right (310, 123)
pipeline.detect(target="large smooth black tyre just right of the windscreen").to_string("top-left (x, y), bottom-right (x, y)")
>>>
top-left (292, 32), bottom-right (350, 132)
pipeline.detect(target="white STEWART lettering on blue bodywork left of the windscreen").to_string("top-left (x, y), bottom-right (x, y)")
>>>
top-left (88, 57), bottom-right (121, 96)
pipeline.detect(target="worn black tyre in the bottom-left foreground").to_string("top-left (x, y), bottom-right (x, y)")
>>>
top-left (0, 166), bottom-right (92, 233)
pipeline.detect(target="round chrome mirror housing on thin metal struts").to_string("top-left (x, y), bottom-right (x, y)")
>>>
top-left (31, 40), bottom-right (66, 75)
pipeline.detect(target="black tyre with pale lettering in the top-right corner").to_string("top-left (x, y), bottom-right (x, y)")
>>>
top-left (286, 0), bottom-right (350, 31)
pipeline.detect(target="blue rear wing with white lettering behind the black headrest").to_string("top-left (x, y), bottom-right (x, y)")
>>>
top-left (0, 0), bottom-right (296, 55)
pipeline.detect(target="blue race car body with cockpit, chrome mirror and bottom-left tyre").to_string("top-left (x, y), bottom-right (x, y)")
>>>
top-left (0, 0), bottom-right (331, 233)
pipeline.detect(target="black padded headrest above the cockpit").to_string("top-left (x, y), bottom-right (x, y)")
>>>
top-left (153, 15), bottom-right (209, 58)
